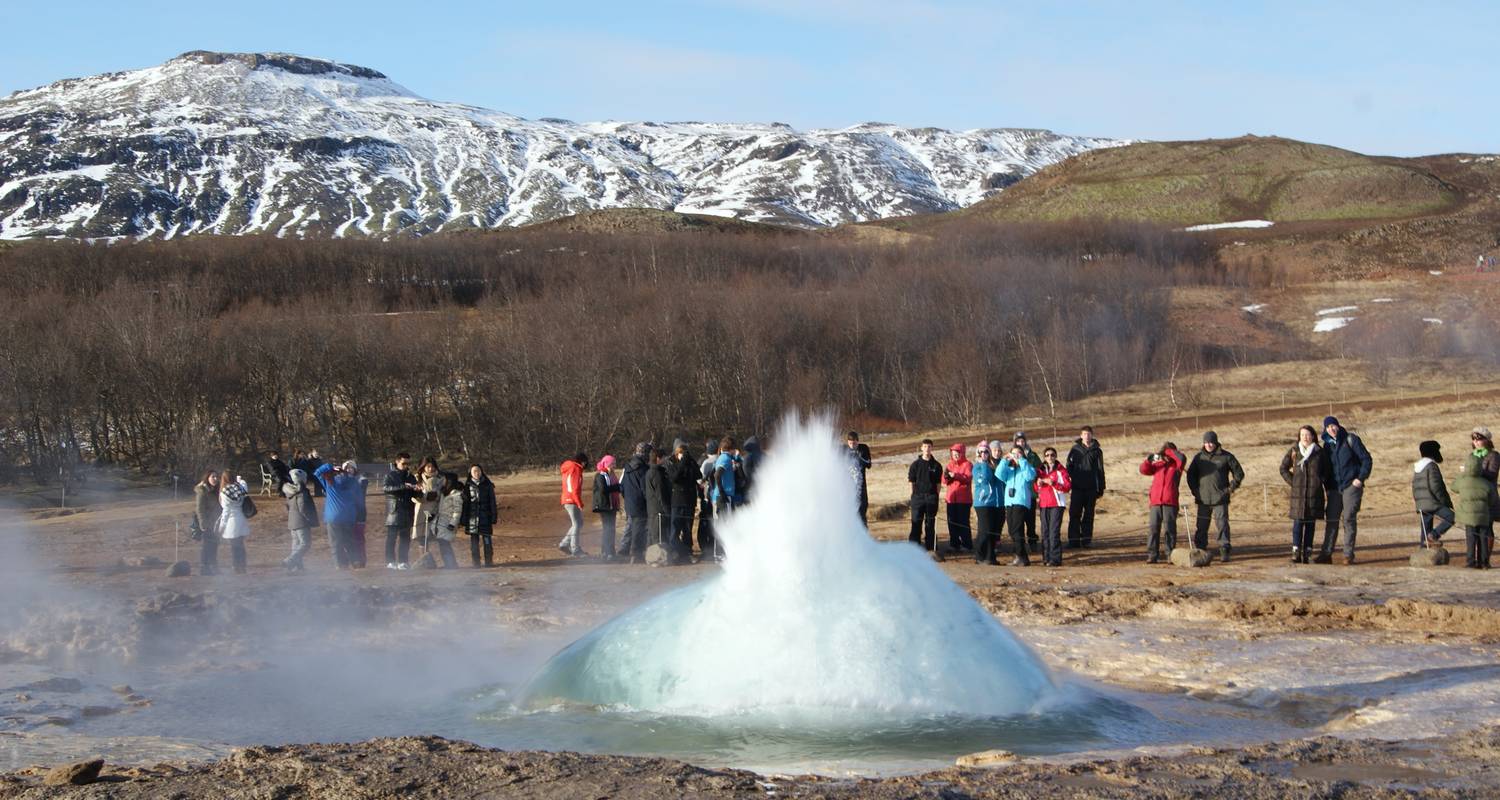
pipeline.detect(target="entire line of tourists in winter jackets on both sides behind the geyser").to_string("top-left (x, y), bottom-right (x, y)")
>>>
top-left (192, 416), bottom-right (1500, 575)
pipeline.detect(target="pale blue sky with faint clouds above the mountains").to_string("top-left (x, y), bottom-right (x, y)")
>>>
top-left (0, 0), bottom-right (1500, 155)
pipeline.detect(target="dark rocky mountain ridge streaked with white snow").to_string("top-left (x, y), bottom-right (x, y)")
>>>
top-left (0, 51), bottom-right (1125, 239)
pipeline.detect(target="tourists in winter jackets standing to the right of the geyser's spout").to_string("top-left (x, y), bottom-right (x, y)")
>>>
top-left (900, 416), bottom-right (1500, 569)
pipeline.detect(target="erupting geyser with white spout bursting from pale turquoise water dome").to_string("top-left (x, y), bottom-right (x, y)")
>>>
top-left (524, 417), bottom-right (1058, 720)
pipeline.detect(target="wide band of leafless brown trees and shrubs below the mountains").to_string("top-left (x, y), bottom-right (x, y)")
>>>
top-left (0, 224), bottom-right (1247, 479)
